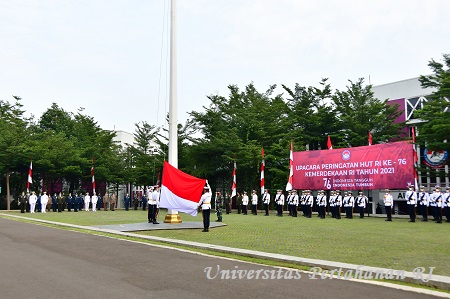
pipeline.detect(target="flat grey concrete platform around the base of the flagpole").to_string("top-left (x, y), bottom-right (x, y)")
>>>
top-left (92, 221), bottom-right (226, 232)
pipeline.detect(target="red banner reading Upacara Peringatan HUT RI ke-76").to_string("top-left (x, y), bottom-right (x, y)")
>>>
top-left (293, 141), bottom-right (414, 190)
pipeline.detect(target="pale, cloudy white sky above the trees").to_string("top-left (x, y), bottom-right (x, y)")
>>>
top-left (0, 0), bottom-right (450, 133)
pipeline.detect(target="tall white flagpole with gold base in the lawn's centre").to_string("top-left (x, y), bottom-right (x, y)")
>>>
top-left (164, 0), bottom-right (182, 223)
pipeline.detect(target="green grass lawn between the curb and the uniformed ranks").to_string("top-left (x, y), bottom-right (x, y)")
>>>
top-left (1, 210), bottom-right (450, 276)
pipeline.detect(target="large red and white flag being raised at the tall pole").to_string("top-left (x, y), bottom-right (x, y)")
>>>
top-left (160, 161), bottom-right (206, 216)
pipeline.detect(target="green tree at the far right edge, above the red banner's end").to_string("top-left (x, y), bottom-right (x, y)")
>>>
top-left (415, 54), bottom-right (450, 152)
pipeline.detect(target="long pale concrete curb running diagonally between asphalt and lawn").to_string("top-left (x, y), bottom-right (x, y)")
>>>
top-left (0, 213), bottom-right (450, 290)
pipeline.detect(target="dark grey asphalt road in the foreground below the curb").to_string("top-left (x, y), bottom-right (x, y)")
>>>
top-left (0, 218), bottom-right (446, 299)
